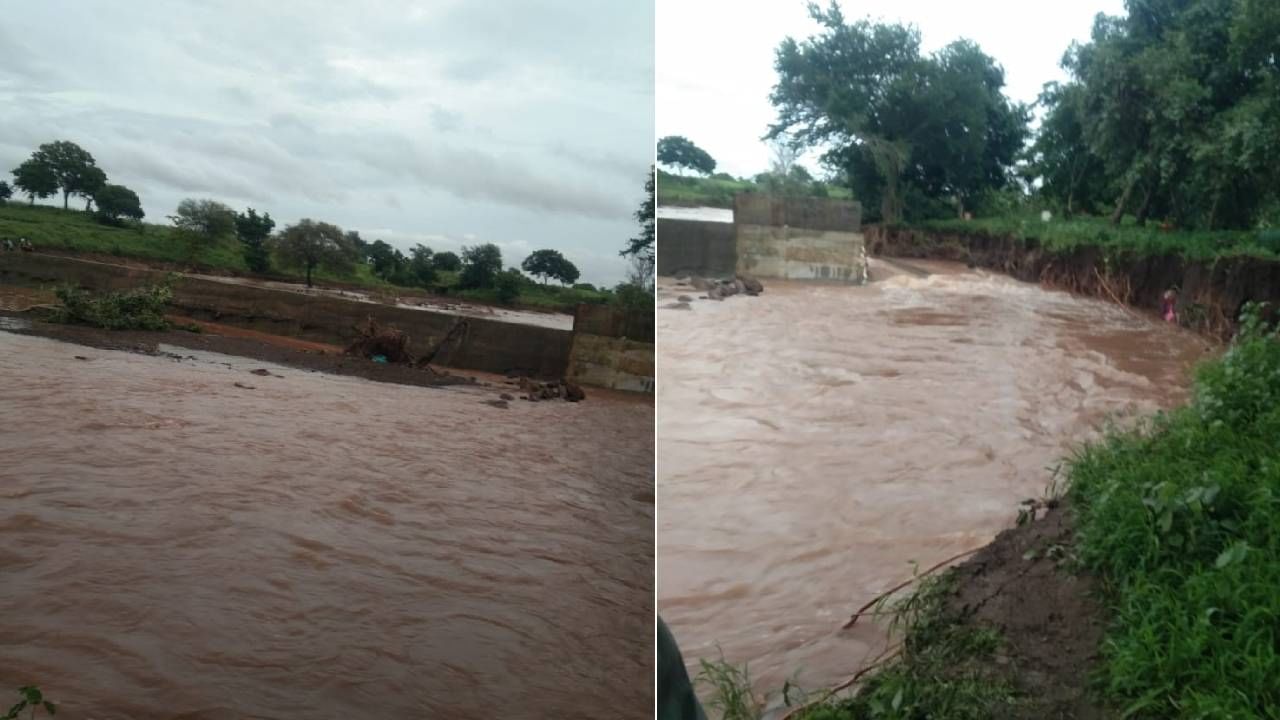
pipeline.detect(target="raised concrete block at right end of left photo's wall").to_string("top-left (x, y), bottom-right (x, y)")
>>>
top-left (567, 305), bottom-right (657, 393)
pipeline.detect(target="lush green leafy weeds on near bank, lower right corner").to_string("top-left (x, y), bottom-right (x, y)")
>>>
top-left (1070, 301), bottom-right (1280, 717)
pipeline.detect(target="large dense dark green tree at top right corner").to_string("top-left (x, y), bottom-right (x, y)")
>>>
top-left (1030, 0), bottom-right (1280, 229)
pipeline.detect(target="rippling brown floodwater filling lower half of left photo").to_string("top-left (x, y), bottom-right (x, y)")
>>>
top-left (0, 332), bottom-right (653, 720)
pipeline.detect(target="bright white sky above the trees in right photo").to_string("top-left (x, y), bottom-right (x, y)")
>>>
top-left (658, 0), bottom-right (1124, 177)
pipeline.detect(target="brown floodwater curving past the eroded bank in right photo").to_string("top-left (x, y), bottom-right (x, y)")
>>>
top-left (658, 264), bottom-right (1210, 692)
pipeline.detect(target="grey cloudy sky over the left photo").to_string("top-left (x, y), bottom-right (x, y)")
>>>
top-left (0, 0), bottom-right (654, 284)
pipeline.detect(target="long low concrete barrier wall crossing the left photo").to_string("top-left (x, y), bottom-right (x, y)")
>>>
top-left (0, 252), bottom-right (573, 379)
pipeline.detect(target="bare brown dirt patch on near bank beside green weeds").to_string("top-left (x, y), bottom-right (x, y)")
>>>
top-left (946, 506), bottom-right (1107, 720)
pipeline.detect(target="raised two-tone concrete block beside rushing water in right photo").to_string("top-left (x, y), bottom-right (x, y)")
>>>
top-left (733, 195), bottom-right (867, 284)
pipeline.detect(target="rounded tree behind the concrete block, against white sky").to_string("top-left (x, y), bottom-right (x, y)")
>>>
top-left (767, 3), bottom-right (1029, 222)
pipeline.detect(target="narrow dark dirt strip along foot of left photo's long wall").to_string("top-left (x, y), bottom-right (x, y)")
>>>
top-left (0, 311), bottom-right (481, 388)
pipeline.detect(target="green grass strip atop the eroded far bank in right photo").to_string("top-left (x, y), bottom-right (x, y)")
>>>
top-left (911, 214), bottom-right (1280, 260)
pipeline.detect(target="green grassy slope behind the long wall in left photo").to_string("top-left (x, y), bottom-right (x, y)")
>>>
top-left (0, 202), bottom-right (614, 311)
